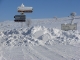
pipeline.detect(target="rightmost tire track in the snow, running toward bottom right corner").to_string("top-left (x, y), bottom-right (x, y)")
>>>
top-left (45, 46), bottom-right (79, 60)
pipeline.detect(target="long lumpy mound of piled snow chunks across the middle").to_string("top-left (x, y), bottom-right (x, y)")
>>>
top-left (0, 26), bottom-right (80, 46)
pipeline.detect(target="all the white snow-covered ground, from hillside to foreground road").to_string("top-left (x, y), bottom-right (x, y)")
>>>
top-left (0, 16), bottom-right (80, 60)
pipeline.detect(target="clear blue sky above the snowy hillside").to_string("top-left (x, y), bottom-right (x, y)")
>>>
top-left (0, 0), bottom-right (80, 21)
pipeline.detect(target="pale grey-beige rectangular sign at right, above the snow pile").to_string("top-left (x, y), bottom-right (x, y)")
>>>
top-left (61, 23), bottom-right (77, 31)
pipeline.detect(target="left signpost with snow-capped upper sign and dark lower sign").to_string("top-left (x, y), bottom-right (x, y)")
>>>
top-left (14, 4), bottom-right (33, 27)
